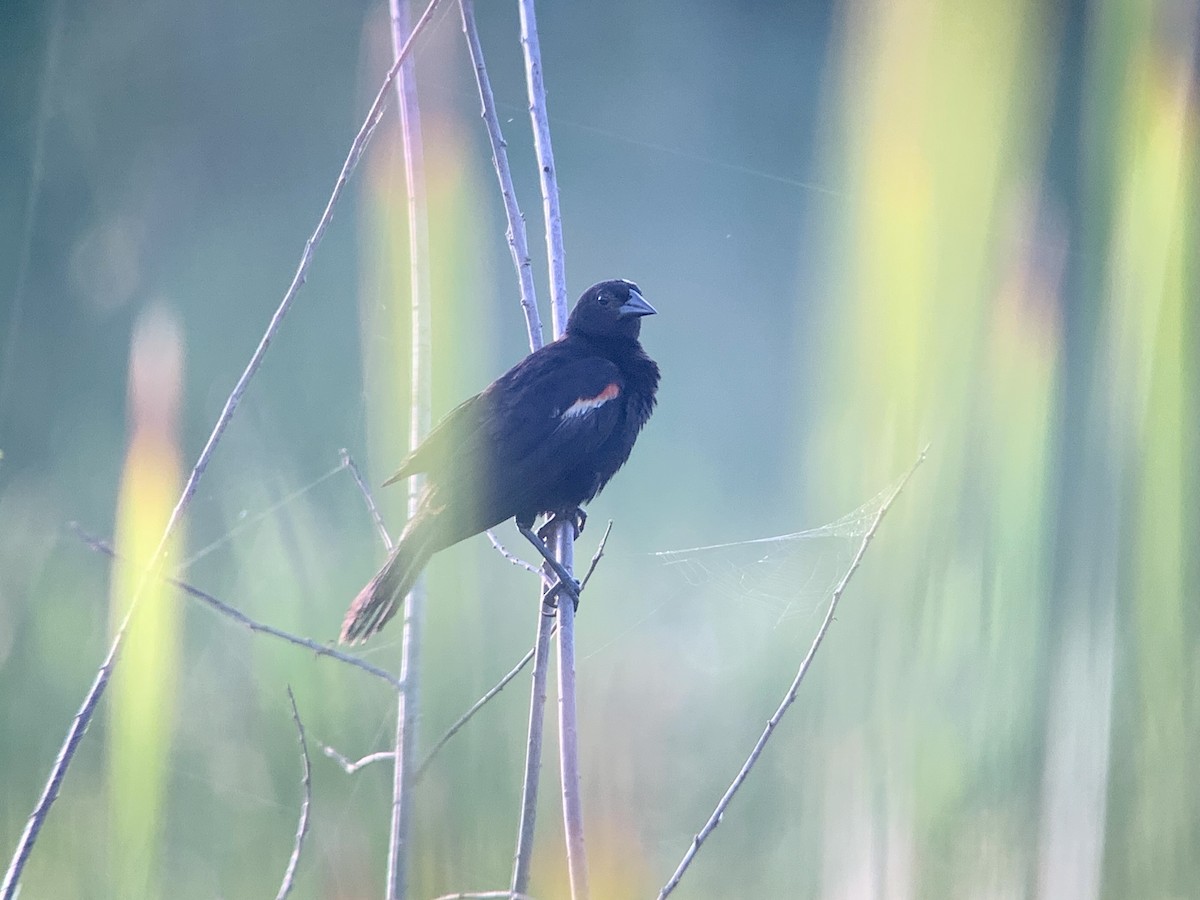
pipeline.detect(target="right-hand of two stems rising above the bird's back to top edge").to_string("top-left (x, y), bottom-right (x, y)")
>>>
top-left (520, 0), bottom-right (568, 337)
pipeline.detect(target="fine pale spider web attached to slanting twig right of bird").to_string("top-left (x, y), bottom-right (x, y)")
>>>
top-left (653, 485), bottom-right (894, 624)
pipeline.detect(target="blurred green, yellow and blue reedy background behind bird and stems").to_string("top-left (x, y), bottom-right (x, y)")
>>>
top-left (0, 0), bottom-right (1200, 898)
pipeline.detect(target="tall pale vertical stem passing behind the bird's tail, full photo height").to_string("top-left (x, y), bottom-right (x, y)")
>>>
top-left (385, 0), bottom-right (432, 900)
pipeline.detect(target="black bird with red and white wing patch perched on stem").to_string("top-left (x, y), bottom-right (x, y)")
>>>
top-left (341, 280), bottom-right (659, 642)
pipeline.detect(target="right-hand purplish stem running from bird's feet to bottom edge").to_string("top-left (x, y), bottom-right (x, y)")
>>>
top-left (553, 526), bottom-right (588, 900)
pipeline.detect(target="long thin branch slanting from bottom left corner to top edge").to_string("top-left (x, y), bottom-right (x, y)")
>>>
top-left (0, 7), bottom-right (440, 900)
